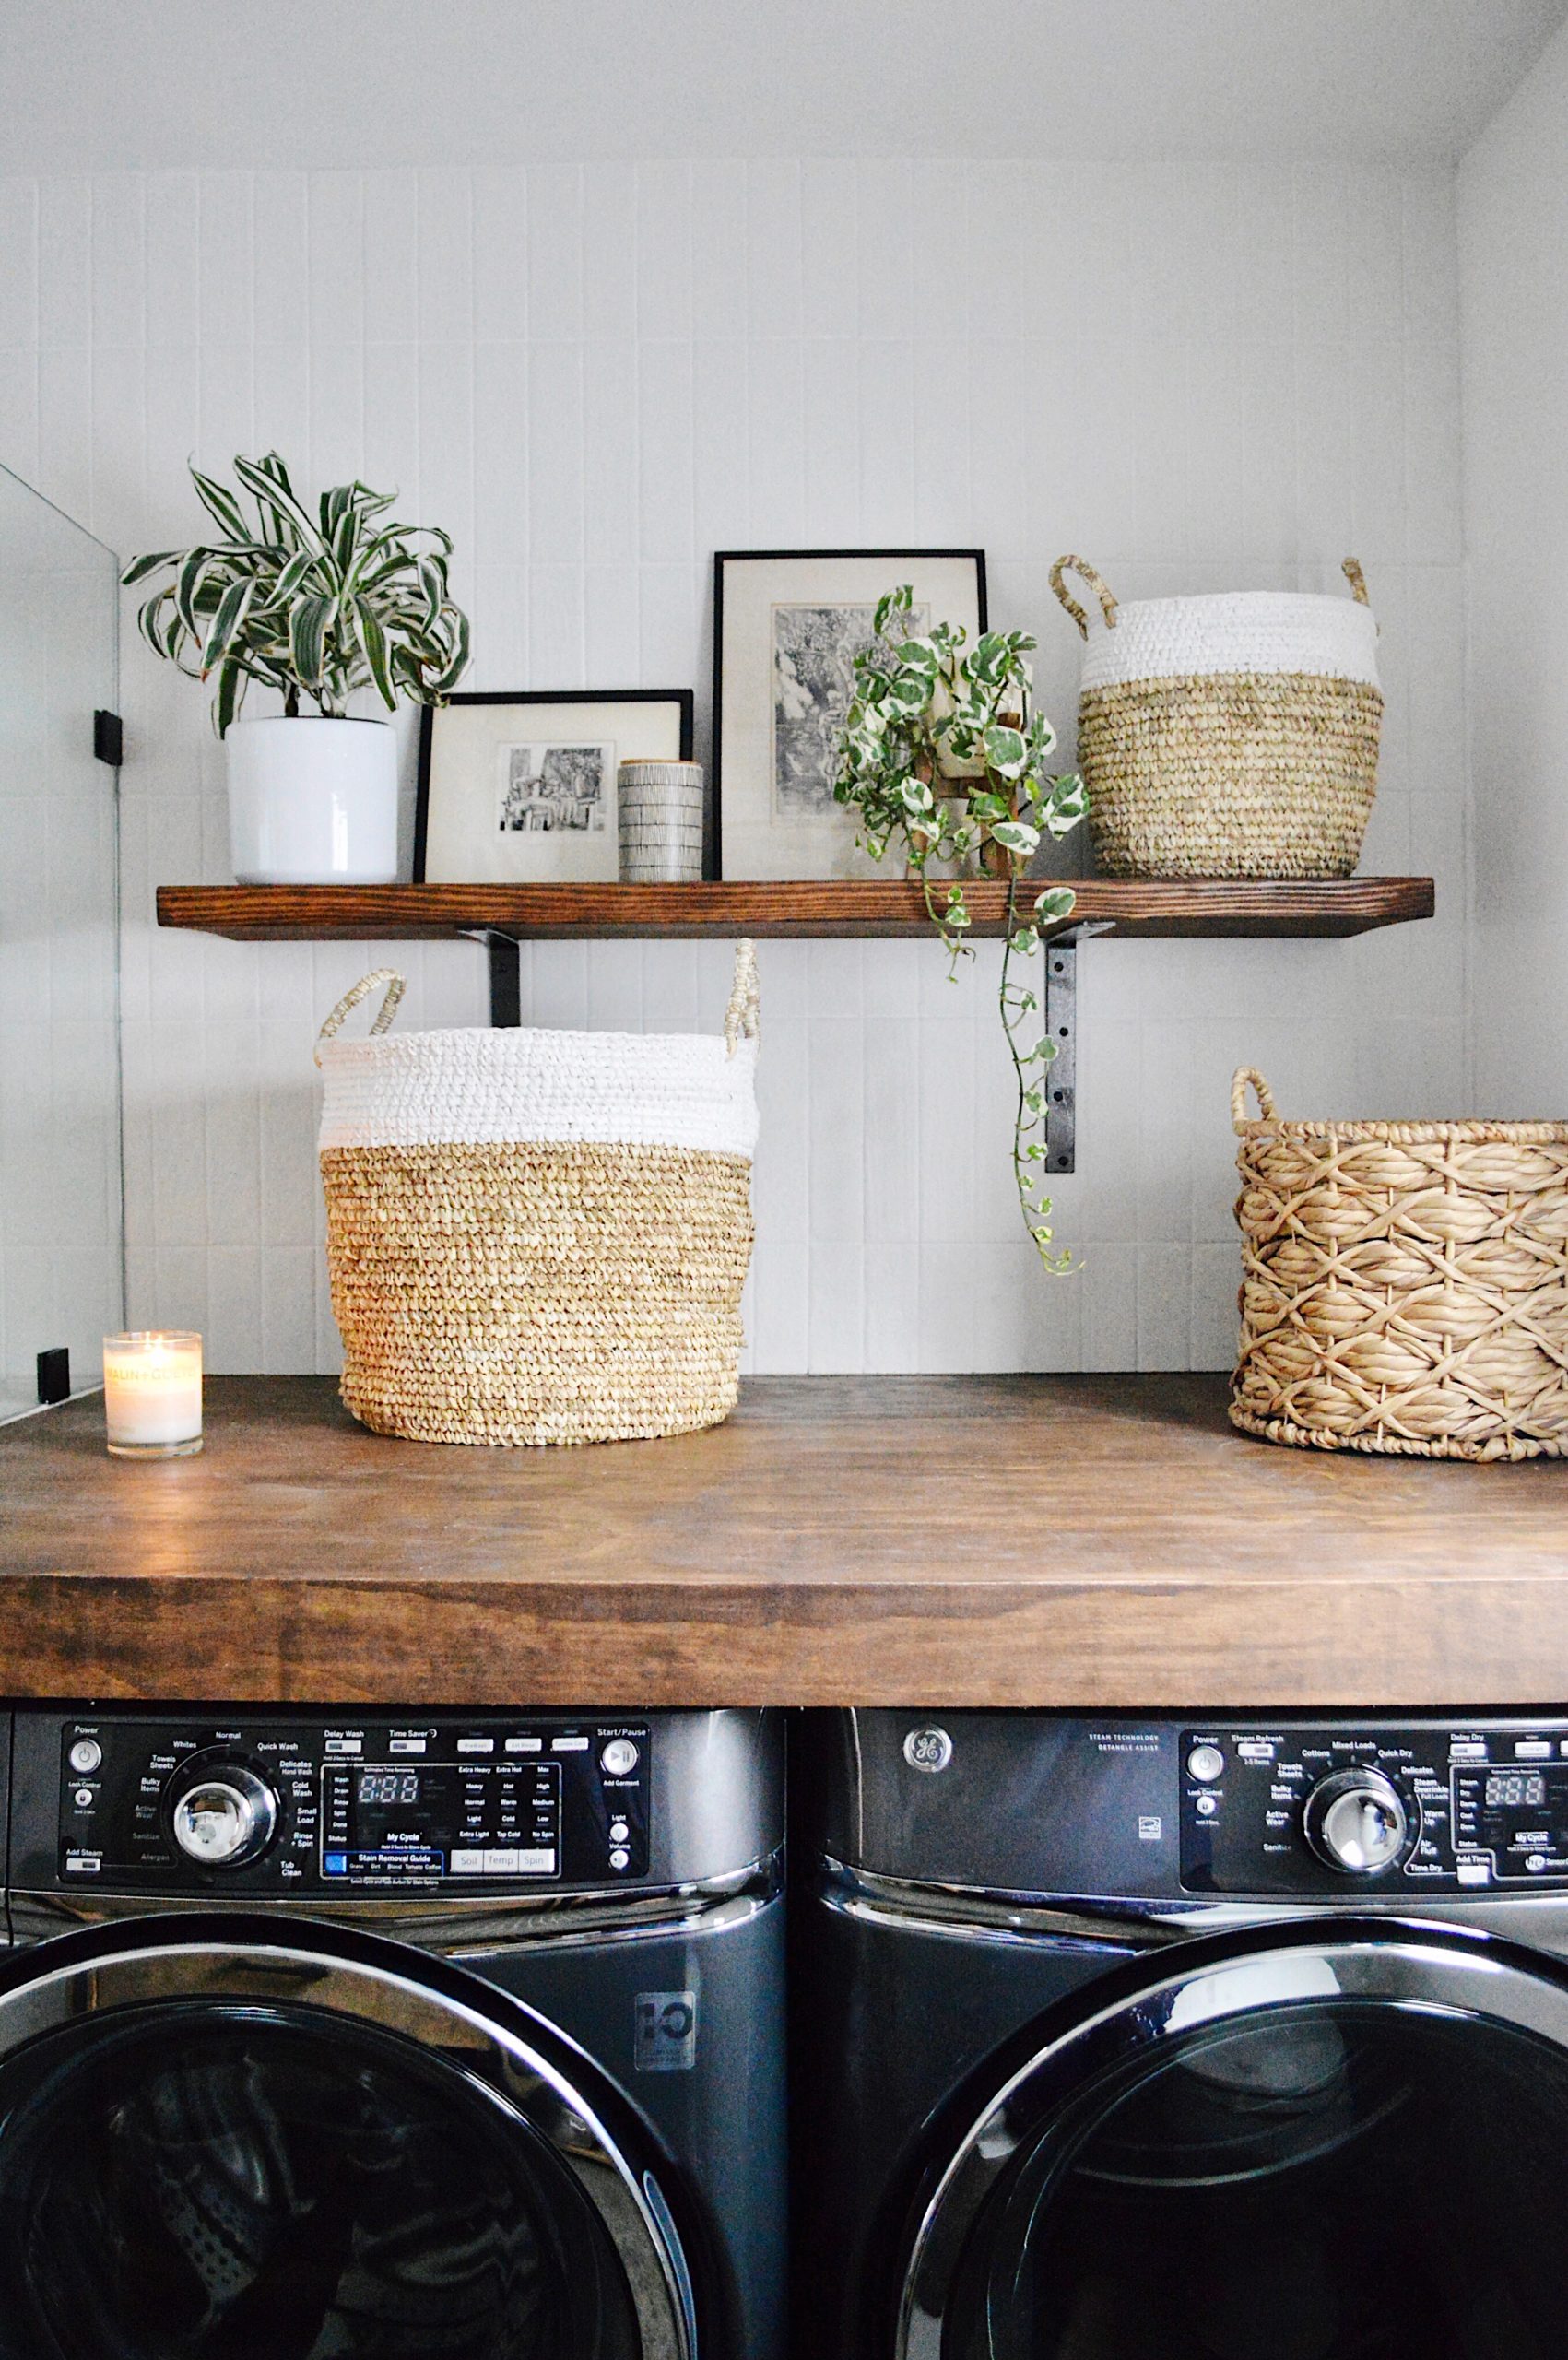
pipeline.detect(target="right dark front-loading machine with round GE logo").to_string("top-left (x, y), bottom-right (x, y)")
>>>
top-left (794, 1711), bottom-right (1568, 2360)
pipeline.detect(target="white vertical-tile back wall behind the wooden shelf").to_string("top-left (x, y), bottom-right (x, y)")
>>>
top-left (0, 159), bottom-right (1467, 1369)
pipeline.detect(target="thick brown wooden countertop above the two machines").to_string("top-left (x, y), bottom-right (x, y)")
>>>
top-left (0, 1375), bottom-right (1568, 1708)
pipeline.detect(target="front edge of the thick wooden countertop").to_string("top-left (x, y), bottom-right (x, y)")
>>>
top-left (0, 1579), bottom-right (1568, 1711)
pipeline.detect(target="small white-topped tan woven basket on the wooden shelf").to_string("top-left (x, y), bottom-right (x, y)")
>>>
top-left (1051, 557), bottom-right (1384, 878)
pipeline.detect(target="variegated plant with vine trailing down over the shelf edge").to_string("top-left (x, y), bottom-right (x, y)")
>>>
top-left (833, 585), bottom-right (1086, 1272)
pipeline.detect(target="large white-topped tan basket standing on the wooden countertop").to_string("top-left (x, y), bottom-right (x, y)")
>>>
top-left (316, 941), bottom-right (758, 1442)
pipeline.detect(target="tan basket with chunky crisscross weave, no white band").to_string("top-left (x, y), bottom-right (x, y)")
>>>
top-left (1231, 1067), bottom-right (1568, 1458)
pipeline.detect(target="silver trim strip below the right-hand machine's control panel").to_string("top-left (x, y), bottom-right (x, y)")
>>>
top-left (817, 1859), bottom-right (1568, 1959)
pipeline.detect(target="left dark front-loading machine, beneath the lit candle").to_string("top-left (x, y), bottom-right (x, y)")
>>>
top-left (0, 1706), bottom-right (784, 2360)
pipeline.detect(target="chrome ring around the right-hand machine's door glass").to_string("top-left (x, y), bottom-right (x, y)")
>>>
top-left (897, 1918), bottom-right (1568, 2360)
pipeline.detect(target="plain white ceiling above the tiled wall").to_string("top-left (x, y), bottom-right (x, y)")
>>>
top-left (0, 0), bottom-right (1568, 171)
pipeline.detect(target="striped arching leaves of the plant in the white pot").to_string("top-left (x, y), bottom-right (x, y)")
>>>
top-left (121, 451), bottom-right (467, 737)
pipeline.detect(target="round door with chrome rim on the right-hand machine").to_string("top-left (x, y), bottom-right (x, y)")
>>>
top-left (897, 1918), bottom-right (1568, 2360)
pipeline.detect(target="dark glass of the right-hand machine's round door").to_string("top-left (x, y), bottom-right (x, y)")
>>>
top-left (940, 1999), bottom-right (1568, 2360)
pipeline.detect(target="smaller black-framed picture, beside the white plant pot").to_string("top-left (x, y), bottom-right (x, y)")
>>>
top-left (413, 690), bottom-right (694, 885)
